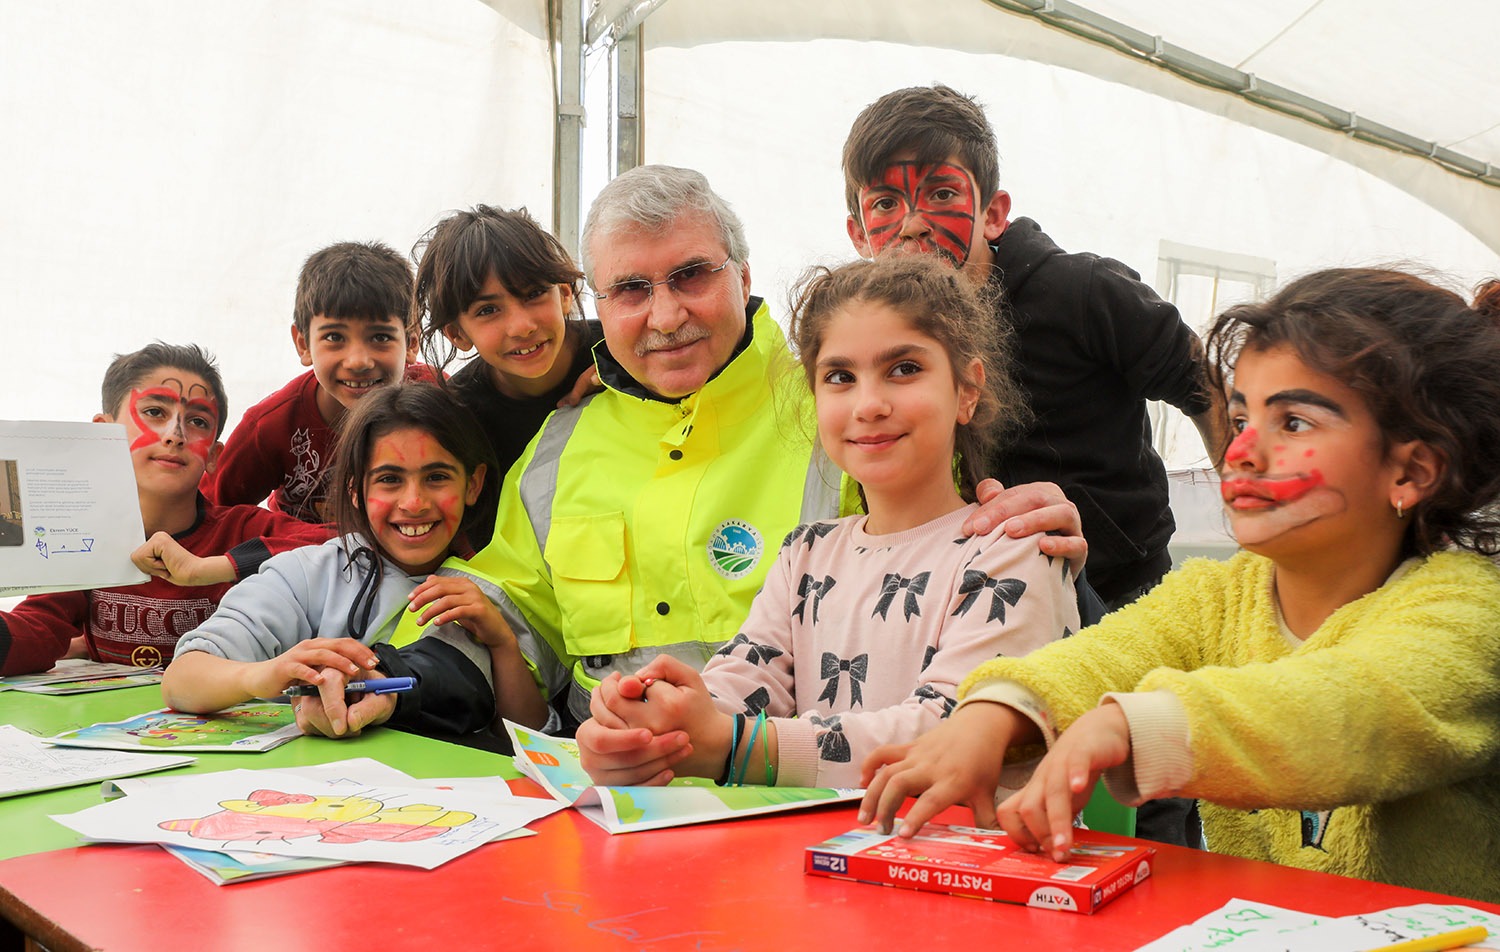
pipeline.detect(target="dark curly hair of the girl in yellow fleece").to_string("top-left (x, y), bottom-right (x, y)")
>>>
top-left (1208, 268), bottom-right (1500, 555)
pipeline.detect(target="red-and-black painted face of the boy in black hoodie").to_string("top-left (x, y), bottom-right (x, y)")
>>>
top-left (860, 162), bottom-right (978, 267)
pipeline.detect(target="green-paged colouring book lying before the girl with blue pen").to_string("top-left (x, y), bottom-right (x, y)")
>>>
top-left (48, 702), bottom-right (302, 753)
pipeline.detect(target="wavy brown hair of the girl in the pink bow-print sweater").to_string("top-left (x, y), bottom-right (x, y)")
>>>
top-left (789, 255), bottom-right (1031, 502)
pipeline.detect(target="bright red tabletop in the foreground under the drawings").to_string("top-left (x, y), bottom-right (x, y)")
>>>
top-left (0, 805), bottom-right (1500, 952)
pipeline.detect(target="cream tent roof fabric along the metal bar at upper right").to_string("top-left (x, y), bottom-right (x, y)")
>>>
top-left (627, 0), bottom-right (1500, 250)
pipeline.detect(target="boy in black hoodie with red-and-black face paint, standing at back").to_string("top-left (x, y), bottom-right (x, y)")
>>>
top-left (843, 85), bottom-right (1227, 846)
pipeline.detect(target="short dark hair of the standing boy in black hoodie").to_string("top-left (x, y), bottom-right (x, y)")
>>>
top-left (843, 82), bottom-right (1001, 222)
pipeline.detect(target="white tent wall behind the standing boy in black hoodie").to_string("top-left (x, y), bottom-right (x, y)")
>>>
top-left (642, 0), bottom-right (1500, 466)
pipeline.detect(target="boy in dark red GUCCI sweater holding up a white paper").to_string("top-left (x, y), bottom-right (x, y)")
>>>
top-left (0, 342), bottom-right (330, 675)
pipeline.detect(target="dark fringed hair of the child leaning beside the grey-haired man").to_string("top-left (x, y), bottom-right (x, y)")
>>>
top-left (408, 205), bottom-right (584, 369)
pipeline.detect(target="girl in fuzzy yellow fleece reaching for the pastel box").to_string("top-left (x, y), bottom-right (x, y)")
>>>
top-left (861, 270), bottom-right (1500, 901)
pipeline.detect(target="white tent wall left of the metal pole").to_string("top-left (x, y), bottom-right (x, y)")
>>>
top-left (0, 0), bottom-right (554, 423)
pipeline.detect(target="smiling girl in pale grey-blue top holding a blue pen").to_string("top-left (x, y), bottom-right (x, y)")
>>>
top-left (162, 384), bottom-right (548, 736)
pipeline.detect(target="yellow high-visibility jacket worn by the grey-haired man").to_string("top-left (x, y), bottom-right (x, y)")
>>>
top-left (396, 298), bottom-right (842, 720)
